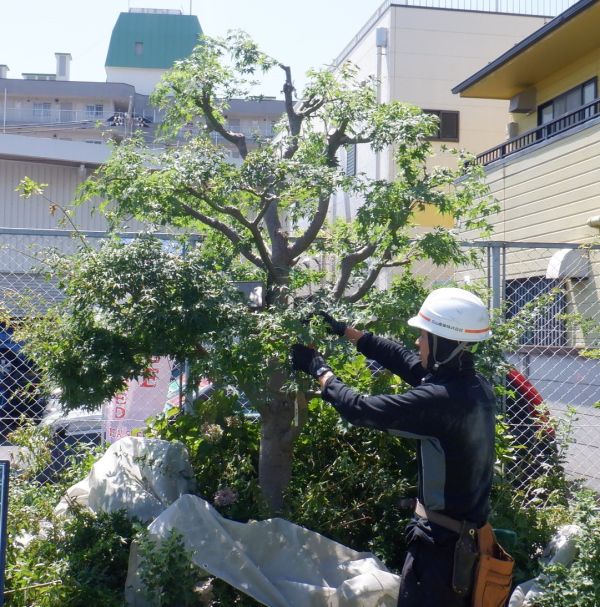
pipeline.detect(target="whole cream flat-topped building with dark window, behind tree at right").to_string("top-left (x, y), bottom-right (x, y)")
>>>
top-left (334, 0), bottom-right (568, 228)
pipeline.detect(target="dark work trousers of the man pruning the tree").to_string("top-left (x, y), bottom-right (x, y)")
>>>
top-left (398, 537), bottom-right (470, 607)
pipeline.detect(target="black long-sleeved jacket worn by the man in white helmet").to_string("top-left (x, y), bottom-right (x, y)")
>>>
top-left (322, 333), bottom-right (496, 525)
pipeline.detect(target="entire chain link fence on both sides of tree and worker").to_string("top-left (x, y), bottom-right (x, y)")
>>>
top-left (0, 229), bottom-right (600, 489)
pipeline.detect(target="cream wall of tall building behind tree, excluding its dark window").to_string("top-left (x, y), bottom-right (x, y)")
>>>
top-left (333, 6), bottom-right (546, 227)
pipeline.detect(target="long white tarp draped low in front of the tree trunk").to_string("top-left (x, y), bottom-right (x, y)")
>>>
top-left (126, 495), bottom-right (400, 607)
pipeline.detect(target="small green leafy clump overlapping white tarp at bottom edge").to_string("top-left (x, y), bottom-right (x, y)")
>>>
top-left (136, 529), bottom-right (204, 607)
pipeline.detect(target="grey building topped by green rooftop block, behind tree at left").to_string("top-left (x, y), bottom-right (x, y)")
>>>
top-left (0, 9), bottom-right (284, 230)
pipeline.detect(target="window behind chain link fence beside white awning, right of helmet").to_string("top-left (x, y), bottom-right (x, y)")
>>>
top-left (506, 276), bottom-right (567, 346)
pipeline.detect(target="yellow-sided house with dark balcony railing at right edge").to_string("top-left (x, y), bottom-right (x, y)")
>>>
top-left (453, 0), bottom-right (600, 346)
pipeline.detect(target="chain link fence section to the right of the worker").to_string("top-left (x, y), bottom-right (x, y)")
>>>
top-left (453, 242), bottom-right (600, 490)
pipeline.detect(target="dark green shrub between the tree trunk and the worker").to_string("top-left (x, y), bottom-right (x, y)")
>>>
top-left (286, 400), bottom-right (416, 571)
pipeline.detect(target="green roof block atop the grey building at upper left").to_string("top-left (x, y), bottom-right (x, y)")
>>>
top-left (105, 12), bottom-right (202, 69)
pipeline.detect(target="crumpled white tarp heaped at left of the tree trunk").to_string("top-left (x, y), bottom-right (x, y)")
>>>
top-left (55, 436), bottom-right (194, 521)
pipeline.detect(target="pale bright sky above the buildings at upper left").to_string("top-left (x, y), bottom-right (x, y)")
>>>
top-left (0, 0), bottom-right (382, 95)
